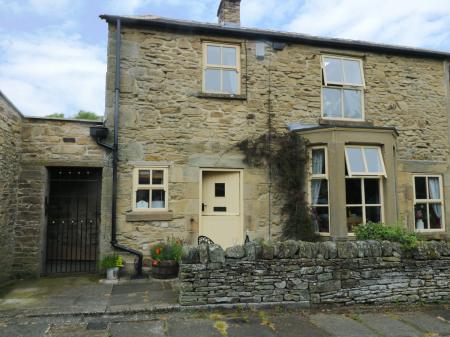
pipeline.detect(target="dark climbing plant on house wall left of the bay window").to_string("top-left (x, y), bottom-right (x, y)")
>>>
top-left (238, 132), bottom-right (318, 241)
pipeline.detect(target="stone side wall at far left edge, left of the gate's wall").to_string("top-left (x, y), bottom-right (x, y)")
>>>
top-left (0, 93), bottom-right (22, 284)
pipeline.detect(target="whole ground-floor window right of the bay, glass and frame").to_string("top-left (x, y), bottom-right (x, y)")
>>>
top-left (414, 175), bottom-right (444, 231)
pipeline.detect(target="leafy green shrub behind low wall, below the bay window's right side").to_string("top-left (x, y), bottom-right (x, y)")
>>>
top-left (354, 222), bottom-right (419, 250)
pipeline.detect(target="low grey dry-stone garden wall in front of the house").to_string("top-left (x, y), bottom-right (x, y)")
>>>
top-left (179, 241), bottom-right (450, 306)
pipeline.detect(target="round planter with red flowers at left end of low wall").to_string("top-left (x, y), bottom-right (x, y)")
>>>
top-left (150, 238), bottom-right (183, 279)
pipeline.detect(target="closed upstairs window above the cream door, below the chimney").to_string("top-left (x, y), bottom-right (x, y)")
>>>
top-left (203, 43), bottom-right (241, 94)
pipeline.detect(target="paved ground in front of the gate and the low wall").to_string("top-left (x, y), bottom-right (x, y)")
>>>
top-left (0, 277), bottom-right (450, 337)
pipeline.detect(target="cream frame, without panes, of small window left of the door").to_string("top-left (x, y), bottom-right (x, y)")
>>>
top-left (131, 166), bottom-right (169, 212)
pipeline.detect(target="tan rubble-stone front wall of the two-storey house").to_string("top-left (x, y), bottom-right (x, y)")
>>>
top-left (106, 24), bottom-right (450, 252)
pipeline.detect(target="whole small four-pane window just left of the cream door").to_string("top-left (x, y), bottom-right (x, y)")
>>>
top-left (133, 167), bottom-right (168, 211)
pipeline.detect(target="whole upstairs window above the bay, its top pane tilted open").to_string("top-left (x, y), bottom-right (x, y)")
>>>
top-left (322, 56), bottom-right (364, 120)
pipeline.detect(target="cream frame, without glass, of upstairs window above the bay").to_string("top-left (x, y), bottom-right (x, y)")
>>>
top-left (320, 55), bottom-right (366, 121)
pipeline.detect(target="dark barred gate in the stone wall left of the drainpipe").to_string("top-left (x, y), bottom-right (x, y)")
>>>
top-left (45, 167), bottom-right (101, 273)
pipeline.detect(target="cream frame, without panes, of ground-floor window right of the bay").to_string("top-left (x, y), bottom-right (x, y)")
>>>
top-left (413, 174), bottom-right (446, 233)
